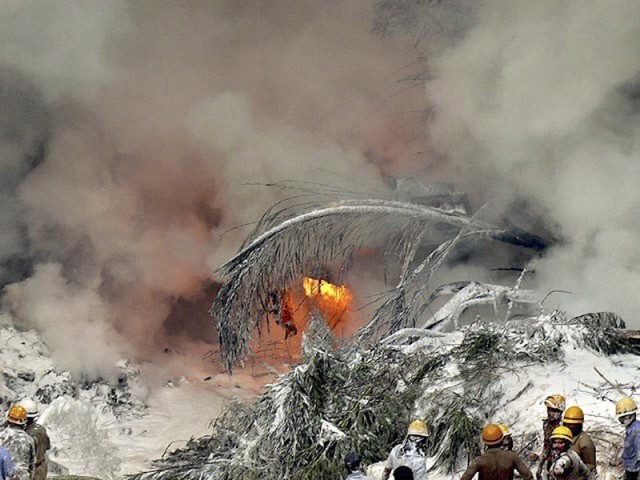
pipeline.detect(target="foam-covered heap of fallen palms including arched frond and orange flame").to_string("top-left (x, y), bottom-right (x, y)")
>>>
top-left (133, 182), bottom-right (636, 479)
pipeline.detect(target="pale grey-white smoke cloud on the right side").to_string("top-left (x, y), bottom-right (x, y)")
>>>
top-left (427, 0), bottom-right (640, 327)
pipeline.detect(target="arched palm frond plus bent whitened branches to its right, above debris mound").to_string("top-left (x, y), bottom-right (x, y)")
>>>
top-left (210, 184), bottom-right (576, 371)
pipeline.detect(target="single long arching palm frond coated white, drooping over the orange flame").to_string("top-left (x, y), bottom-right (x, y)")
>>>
top-left (211, 200), bottom-right (480, 369)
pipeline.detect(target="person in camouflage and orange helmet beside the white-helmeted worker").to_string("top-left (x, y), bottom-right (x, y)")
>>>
top-left (0, 405), bottom-right (36, 480)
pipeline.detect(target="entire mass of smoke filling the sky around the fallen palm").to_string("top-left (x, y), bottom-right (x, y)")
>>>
top-left (0, 0), bottom-right (640, 374)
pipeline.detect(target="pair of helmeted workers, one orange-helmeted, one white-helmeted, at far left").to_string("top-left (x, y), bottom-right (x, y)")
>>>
top-left (0, 398), bottom-right (51, 480)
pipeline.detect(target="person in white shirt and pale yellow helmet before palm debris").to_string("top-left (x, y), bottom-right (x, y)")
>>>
top-left (382, 420), bottom-right (429, 480)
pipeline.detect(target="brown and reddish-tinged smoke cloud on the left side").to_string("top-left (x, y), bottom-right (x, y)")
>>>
top-left (0, 0), bottom-right (421, 373)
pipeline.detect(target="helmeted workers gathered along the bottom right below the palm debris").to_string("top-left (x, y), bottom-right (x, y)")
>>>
top-left (345, 393), bottom-right (640, 480)
